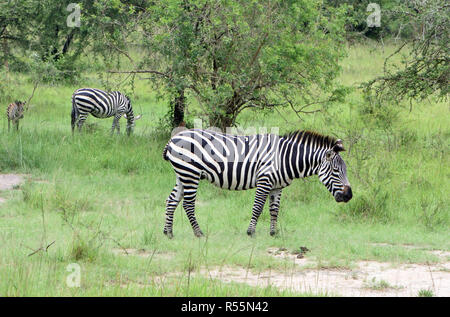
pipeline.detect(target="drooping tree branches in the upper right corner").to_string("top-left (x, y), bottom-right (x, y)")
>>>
top-left (364, 0), bottom-right (450, 101)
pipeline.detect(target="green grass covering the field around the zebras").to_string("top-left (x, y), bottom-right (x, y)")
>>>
top-left (0, 46), bottom-right (450, 296)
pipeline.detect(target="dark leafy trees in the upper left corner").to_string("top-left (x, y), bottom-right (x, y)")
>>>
top-left (0, 0), bottom-right (142, 77)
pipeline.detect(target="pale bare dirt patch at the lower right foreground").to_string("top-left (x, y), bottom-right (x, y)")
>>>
top-left (200, 248), bottom-right (450, 297)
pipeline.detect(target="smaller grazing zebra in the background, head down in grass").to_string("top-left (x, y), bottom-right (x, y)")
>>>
top-left (72, 88), bottom-right (141, 135)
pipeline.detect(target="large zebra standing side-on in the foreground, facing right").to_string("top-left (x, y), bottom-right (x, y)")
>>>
top-left (163, 129), bottom-right (352, 238)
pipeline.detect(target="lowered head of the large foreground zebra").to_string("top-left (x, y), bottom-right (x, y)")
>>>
top-left (318, 140), bottom-right (353, 202)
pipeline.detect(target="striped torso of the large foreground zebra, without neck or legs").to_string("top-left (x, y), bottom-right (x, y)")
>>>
top-left (163, 129), bottom-right (279, 190)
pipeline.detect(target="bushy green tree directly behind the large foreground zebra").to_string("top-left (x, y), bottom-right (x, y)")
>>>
top-left (136, 0), bottom-right (346, 128)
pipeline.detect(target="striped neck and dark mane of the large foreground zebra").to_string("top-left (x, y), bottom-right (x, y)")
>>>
top-left (280, 131), bottom-right (335, 179)
